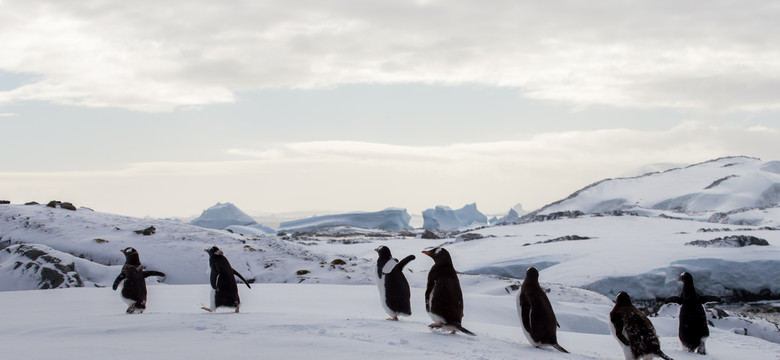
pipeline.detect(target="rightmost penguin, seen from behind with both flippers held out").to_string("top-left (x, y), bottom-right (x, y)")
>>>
top-left (666, 272), bottom-right (717, 355)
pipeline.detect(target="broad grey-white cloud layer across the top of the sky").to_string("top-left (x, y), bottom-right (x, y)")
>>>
top-left (0, 0), bottom-right (780, 111)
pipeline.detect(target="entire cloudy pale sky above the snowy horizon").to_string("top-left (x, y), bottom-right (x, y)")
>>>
top-left (0, 0), bottom-right (780, 217)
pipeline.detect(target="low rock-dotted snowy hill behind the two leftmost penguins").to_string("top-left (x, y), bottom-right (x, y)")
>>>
top-left (0, 205), bottom-right (380, 290)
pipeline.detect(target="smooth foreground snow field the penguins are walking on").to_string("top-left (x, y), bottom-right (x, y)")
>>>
top-left (0, 284), bottom-right (780, 360)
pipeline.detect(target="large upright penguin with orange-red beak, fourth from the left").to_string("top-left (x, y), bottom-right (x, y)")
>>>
top-left (422, 247), bottom-right (476, 336)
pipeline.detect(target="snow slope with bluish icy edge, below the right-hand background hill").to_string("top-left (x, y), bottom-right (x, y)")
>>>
top-left (464, 216), bottom-right (780, 299)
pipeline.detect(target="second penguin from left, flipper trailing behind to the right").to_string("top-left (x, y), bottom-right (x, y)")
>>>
top-left (201, 246), bottom-right (252, 312)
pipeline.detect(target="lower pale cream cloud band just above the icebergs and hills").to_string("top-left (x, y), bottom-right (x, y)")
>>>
top-left (0, 122), bottom-right (780, 217)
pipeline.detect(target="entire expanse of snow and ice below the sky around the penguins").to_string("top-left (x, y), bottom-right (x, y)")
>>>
top-left (0, 157), bottom-right (780, 360)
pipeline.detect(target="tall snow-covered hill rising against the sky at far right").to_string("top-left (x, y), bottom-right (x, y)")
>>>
top-left (523, 157), bottom-right (780, 226)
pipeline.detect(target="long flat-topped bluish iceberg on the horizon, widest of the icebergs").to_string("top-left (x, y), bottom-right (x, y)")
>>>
top-left (279, 208), bottom-right (412, 231)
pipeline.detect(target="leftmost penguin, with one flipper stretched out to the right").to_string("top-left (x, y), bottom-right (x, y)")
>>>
top-left (112, 247), bottom-right (165, 314)
